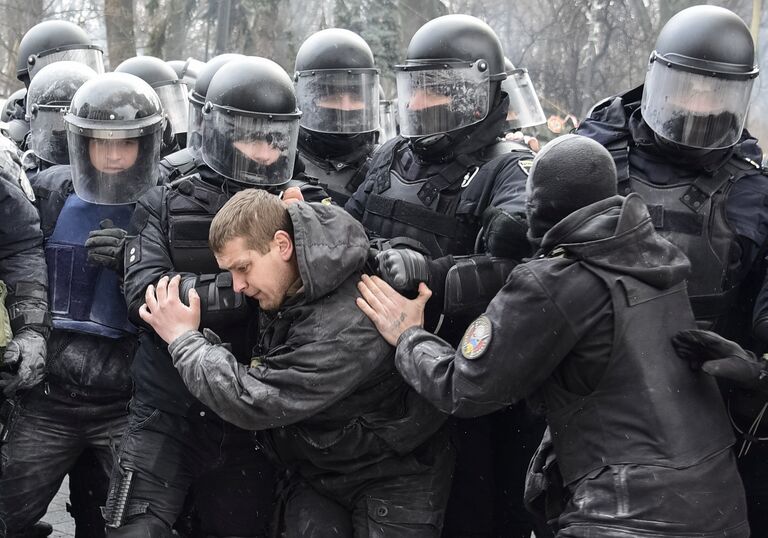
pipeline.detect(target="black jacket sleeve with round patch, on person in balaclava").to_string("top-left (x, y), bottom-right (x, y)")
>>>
top-left (395, 264), bottom-right (591, 417)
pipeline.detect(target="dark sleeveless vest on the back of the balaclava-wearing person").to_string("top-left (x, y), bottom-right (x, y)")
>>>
top-left (545, 264), bottom-right (733, 484)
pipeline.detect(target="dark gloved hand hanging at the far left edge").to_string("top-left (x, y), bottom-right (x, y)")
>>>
top-left (0, 329), bottom-right (48, 398)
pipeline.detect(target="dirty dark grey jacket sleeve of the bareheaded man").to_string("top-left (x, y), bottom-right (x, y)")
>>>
top-left (169, 275), bottom-right (393, 430)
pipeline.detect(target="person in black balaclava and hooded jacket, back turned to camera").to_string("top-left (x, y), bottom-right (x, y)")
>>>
top-left (358, 135), bottom-right (749, 538)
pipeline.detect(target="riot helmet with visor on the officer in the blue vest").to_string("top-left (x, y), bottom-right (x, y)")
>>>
top-left (64, 73), bottom-right (165, 205)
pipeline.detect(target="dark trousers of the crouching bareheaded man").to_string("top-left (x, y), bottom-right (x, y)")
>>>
top-left (280, 433), bottom-right (454, 538)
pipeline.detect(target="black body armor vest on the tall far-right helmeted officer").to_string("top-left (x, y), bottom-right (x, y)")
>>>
top-left (608, 141), bottom-right (760, 329)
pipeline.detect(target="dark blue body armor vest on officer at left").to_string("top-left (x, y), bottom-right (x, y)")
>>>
top-left (45, 194), bottom-right (136, 338)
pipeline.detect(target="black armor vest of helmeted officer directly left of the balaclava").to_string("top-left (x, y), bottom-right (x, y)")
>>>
top-left (362, 138), bottom-right (530, 258)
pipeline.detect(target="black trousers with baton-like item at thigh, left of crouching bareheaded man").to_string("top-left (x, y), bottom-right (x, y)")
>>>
top-left (104, 399), bottom-right (274, 538)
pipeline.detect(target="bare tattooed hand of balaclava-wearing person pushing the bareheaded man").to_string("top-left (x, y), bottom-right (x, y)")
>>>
top-left (356, 275), bottom-right (432, 346)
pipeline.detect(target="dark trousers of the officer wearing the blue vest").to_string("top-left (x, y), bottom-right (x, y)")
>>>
top-left (0, 384), bottom-right (128, 538)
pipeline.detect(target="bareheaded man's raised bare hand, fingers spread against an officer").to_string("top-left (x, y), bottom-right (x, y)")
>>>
top-left (139, 275), bottom-right (200, 344)
